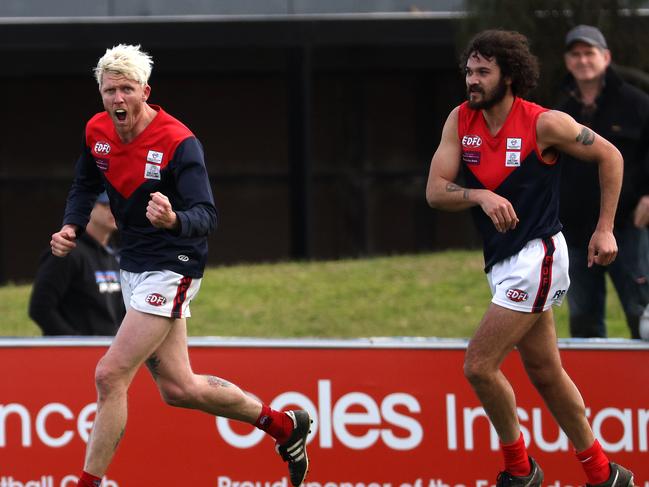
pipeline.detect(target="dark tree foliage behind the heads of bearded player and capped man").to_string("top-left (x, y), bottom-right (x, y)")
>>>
top-left (458, 0), bottom-right (649, 105)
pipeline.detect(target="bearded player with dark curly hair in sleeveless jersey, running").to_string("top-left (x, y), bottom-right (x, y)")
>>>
top-left (426, 30), bottom-right (633, 487)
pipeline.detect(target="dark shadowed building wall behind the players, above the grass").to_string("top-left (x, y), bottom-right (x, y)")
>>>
top-left (0, 19), bottom-right (477, 281)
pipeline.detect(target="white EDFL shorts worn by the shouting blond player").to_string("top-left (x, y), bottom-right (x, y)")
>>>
top-left (120, 270), bottom-right (201, 318)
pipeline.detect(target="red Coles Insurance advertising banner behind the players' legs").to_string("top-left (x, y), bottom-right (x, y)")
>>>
top-left (0, 340), bottom-right (649, 487)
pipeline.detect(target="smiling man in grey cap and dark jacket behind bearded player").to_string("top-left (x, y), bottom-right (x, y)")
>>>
top-left (557, 25), bottom-right (649, 338)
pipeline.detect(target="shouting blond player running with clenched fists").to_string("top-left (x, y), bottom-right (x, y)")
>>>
top-left (51, 44), bottom-right (311, 487)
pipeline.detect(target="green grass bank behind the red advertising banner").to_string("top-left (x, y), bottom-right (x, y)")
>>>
top-left (0, 251), bottom-right (628, 338)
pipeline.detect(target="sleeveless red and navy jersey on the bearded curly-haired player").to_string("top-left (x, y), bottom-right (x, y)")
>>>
top-left (458, 97), bottom-right (561, 272)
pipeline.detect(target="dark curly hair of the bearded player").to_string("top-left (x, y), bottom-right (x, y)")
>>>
top-left (460, 30), bottom-right (539, 96)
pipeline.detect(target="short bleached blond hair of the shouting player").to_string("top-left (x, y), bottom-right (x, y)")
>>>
top-left (94, 44), bottom-right (153, 88)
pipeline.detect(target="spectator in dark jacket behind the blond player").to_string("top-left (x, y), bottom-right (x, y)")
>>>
top-left (29, 193), bottom-right (126, 335)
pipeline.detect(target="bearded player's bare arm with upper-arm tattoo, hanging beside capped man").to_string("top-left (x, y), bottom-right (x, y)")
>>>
top-left (536, 111), bottom-right (624, 267)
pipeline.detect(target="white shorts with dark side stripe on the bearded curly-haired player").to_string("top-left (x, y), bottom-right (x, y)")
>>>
top-left (487, 232), bottom-right (570, 313)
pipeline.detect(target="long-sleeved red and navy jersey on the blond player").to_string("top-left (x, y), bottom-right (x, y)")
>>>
top-left (63, 105), bottom-right (216, 278)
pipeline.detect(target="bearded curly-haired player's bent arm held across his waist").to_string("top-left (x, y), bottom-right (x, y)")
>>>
top-left (426, 108), bottom-right (518, 232)
